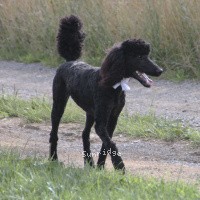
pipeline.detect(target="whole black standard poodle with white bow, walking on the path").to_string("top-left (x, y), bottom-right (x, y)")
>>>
top-left (49, 15), bottom-right (163, 170)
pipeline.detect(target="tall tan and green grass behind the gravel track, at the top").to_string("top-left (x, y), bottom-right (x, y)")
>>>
top-left (0, 0), bottom-right (200, 80)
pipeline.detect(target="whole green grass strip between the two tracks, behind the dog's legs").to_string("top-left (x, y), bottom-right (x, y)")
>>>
top-left (0, 95), bottom-right (200, 145)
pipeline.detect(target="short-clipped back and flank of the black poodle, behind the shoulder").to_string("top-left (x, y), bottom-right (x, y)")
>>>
top-left (54, 61), bottom-right (100, 111)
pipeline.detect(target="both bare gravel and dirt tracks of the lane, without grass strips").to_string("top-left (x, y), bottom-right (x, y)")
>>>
top-left (0, 61), bottom-right (200, 185)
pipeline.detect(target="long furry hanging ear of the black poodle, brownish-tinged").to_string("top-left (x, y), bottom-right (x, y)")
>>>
top-left (100, 46), bottom-right (125, 87)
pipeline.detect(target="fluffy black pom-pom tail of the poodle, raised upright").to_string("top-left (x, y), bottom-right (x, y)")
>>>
top-left (57, 15), bottom-right (85, 61)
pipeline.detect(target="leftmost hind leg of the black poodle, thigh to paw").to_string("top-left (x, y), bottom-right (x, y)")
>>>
top-left (49, 76), bottom-right (69, 160)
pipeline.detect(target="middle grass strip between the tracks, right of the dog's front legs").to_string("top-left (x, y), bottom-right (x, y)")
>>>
top-left (117, 113), bottom-right (200, 145)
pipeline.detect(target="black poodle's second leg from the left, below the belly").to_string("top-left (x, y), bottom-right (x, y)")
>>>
top-left (82, 113), bottom-right (94, 166)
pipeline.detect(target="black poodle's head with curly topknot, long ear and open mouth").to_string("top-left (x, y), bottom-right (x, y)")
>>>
top-left (101, 39), bottom-right (163, 87)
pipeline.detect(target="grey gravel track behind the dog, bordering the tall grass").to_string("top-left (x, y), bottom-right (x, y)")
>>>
top-left (0, 61), bottom-right (200, 127)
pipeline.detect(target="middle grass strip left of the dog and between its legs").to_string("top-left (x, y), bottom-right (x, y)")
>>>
top-left (0, 95), bottom-right (84, 123)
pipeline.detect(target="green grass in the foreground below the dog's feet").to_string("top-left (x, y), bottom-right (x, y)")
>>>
top-left (0, 150), bottom-right (200, 200)
